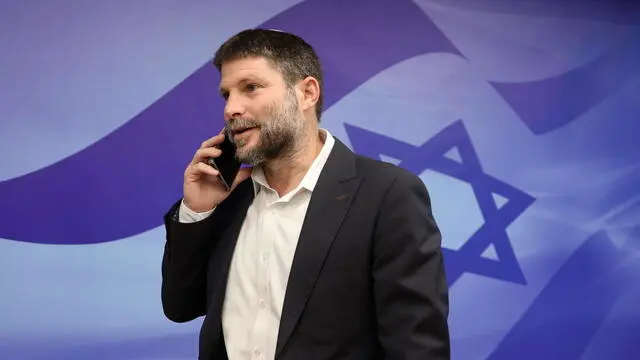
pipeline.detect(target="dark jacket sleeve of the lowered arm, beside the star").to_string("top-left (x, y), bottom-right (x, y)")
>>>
top-left (372, 170), bottom-right (451, 360)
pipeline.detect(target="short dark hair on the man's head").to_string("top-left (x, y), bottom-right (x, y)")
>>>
top-left (213, 29), bottom-right (323, 121)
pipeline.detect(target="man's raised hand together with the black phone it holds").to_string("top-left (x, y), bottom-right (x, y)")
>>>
top-left (183, 133), bottom-right (251, 212)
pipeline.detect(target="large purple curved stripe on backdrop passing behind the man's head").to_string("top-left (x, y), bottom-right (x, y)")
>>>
top-left (0, 0), bottom-right (460, 244)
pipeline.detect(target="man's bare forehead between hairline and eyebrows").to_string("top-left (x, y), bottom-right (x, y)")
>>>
top-left (220, 57), bottom-right (282, 88)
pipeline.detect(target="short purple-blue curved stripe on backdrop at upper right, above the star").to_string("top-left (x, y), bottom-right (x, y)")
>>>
top-left (492, 35), bottom-right (640, 135)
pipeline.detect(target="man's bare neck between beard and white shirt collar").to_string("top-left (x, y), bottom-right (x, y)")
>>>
top-left (263, 126), bottom-right (324, 196)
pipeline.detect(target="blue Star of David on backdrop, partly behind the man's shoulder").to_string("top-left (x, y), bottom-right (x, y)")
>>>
top-left (345, 120), bottom-right (534, 285)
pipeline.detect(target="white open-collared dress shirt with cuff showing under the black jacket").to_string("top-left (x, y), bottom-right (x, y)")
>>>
top-left (179, 129), bottom-right (335, 360)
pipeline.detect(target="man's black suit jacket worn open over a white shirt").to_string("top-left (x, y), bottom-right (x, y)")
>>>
top-left (162, 139), bottom-right (450, 360)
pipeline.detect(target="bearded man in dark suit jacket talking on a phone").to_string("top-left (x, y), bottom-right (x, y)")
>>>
top-left (162, 30), bottom-right (450, 360)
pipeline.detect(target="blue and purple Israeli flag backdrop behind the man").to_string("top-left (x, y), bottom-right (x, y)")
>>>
top-left (0, 0), bottom-right (640, 360)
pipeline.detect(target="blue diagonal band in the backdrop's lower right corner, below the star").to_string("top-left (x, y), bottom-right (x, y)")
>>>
top-left (488, 231), bottom-right (640, 360)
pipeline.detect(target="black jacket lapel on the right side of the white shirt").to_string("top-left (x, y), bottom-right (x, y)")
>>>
top-left (276, 139), bottom-right (360, 358)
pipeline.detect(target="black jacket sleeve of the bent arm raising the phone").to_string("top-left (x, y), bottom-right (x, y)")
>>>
top-left (161, 201), bottom-right (224, 322)
